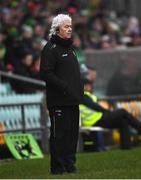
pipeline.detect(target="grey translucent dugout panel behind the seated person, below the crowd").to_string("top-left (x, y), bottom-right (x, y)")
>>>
top-left (87, 48), bottom-right (141, 98)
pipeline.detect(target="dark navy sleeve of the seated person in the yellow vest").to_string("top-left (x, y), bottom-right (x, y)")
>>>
top-left (82, 95), bottom-right (108, 113)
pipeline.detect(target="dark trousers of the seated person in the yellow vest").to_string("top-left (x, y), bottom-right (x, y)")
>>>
top-left (95, 109), bottom-right (141, 149)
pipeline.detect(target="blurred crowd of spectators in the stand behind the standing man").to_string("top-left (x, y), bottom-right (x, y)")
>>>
top-left (0, 0), bottom-right (141, 79)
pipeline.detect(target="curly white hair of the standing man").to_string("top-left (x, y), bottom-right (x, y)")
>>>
top-left (49, 14), bottom-right (72, 39)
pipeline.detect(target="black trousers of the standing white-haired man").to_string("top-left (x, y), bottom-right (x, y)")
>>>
top-left (49, 106), bottom-right (79, 173)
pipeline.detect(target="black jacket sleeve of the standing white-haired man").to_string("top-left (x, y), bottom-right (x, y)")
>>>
top-left (40, 46), bottom-right (67, 93)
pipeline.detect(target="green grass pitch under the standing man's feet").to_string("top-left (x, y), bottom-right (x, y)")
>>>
top-left (0, 147), bottom-right (141, 179)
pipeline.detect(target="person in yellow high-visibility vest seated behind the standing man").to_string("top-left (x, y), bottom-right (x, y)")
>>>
top-left (80, 79), bottom-right (141, 149)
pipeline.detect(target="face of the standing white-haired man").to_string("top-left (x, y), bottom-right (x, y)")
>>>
top-left (57, 20), bottom-right (72, 39)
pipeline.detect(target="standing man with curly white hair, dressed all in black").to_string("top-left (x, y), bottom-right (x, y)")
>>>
top-left (40, 14), bottom-right (83, 174)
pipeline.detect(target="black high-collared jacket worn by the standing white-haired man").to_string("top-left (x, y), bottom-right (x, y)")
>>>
top-left (40, 35), bottom-right (83, 107)
